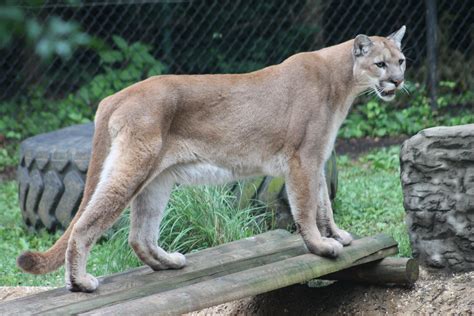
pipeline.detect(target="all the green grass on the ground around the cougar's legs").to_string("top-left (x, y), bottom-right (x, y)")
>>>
top-left (0, 148), bottom-right (411, 286)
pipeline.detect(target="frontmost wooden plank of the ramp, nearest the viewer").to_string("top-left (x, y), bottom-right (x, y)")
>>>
top-left (77, 235), bottom-right (397, 315)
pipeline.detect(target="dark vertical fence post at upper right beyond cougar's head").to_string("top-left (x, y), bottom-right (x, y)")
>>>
top-left (425, 0), bottom-right (438, 110)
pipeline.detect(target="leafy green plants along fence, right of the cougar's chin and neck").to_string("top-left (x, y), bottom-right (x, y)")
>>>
top-left (339, 81), bottom-right (474, 138)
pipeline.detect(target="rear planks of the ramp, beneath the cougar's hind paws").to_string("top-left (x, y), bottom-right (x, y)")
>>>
top-left (0, 230), bottom-right (397, 315)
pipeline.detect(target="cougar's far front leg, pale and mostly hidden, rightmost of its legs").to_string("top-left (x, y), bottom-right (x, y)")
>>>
top-left (317, 169), bottom-right (353, 246)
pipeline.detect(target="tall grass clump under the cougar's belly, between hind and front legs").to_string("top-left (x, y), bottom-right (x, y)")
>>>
top-left (161, 186), bottom-right (274, 252)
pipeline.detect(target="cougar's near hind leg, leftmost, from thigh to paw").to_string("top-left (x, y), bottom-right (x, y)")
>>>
top-left (66, 131), bottom-right (161, 292)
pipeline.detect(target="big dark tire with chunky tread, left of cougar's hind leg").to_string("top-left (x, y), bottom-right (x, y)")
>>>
top-left (17, 123), bottom-right (94, 232)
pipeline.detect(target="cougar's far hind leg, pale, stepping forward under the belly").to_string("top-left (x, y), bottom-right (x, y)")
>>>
top-left (129, 174), bottom-right (186, 271)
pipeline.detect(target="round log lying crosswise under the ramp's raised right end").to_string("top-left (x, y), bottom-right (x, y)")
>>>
top-left (322, 257), bottom-right (419, 285)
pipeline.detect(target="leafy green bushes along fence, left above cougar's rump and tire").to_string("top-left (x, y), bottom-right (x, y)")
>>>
top-left (0, 36), bottom-right (166, 140)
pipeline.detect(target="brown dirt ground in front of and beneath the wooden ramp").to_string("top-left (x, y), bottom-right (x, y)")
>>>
top-left (0, 269), bottom-right (474, 316)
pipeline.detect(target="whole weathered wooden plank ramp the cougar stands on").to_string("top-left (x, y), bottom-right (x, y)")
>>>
top-left (0, 230), bottom-right (418, 316)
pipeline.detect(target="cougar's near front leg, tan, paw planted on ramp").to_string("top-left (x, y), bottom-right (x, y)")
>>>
top-left (285, 158), bottom-right (342, 257)
